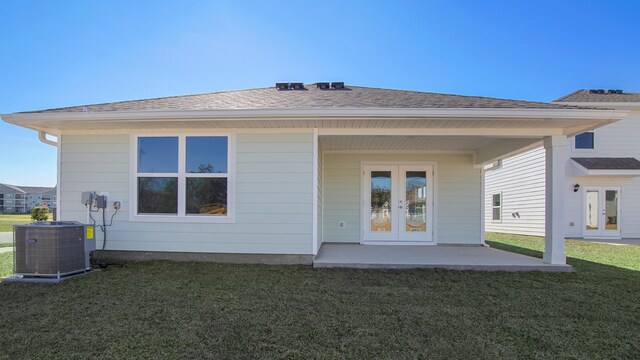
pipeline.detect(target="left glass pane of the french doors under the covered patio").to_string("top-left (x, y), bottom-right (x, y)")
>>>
top-left (370, 171), bottom-right (393, 232)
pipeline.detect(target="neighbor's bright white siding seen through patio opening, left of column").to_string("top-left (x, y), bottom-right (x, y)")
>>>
top-left (485, 147), bottom-right (545, 236)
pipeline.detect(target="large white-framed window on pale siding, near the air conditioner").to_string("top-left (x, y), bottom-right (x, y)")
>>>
top-left (131, 135), bottom-right (234, 222)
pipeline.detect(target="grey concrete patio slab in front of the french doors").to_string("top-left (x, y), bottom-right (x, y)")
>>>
top-left (313, 243), bottom-right (573, 272)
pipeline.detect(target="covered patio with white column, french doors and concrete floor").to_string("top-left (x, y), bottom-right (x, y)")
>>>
top-left (313, 108), bottom-right (632, 272)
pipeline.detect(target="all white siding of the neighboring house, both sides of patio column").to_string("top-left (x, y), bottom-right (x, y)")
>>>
top-left (485, 111), bottom-right (640, 238)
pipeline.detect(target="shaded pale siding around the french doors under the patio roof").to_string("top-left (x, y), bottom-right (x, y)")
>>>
top-left (322, 153), bottom-right (481, 244)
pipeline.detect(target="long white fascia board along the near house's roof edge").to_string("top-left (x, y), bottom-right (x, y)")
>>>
top-left (0, 108), bottom-right (627, 124)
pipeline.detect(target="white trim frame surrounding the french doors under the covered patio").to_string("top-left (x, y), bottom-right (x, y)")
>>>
top-left (360, 160), bottom-right (438, 245)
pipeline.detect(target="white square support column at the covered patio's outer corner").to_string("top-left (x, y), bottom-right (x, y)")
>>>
top-left (543, 135), bottom-right (567, 265)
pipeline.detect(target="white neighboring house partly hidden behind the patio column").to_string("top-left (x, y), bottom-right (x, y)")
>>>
top-left (485, 90), bottom-right (640, 239)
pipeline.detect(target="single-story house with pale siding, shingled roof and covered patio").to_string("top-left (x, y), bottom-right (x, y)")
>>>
top-left (2, 83), bottom-right (626, 265)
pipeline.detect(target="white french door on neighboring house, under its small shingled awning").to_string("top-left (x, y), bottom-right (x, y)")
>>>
top-left (582, 186), bottom-right (620, 238)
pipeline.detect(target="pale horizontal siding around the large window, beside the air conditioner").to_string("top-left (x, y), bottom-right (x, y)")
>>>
top-left (59, 132), bottom-right (313, 254)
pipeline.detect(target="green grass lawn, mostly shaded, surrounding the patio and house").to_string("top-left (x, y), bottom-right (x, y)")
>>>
top-left (0, 234), bottom-right (640, 359)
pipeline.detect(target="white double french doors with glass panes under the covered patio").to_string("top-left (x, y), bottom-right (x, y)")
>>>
top-left (362, 164), bottom-right (434, 243)
